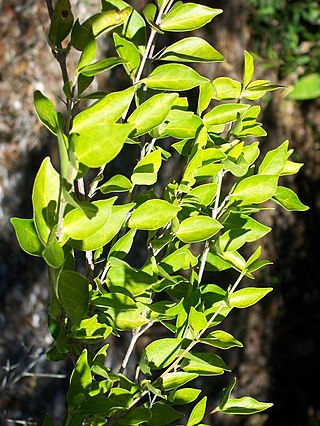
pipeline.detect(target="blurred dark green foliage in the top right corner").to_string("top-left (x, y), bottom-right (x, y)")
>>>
top-left (247, 0), bottom-right (320, 75)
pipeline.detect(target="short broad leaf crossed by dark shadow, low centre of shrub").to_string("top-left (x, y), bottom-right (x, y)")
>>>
top-left (145, 338), bottom-right (183, 370)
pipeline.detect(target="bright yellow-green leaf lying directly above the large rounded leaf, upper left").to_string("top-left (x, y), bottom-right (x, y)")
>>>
top-left (71, 87), bottom-right (134, 134)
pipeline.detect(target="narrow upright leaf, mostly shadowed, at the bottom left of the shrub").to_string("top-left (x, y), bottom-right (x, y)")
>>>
top-left (67, 349), bottom-right (92, 407)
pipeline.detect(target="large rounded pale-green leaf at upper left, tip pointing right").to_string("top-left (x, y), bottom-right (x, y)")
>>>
top-left (74, 124), bottom-right (134, 168)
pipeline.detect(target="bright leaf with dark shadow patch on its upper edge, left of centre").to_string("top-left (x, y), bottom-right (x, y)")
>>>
top-left (63, 197), bottom-right (116, 240)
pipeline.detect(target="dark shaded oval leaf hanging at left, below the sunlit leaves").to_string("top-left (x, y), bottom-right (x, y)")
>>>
top-left (58, 271), bottom-right (89, 326)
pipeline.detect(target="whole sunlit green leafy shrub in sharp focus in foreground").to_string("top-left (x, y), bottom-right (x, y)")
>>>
top-left (12, 0), bottom-right (307, 426)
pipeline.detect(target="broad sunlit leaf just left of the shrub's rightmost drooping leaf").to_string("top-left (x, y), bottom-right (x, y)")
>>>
top-left (230, 175), bottom-right (278, 205)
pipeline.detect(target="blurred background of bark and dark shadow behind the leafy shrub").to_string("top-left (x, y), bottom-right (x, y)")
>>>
top-left (0, 0), bottom-right (320, 426)
